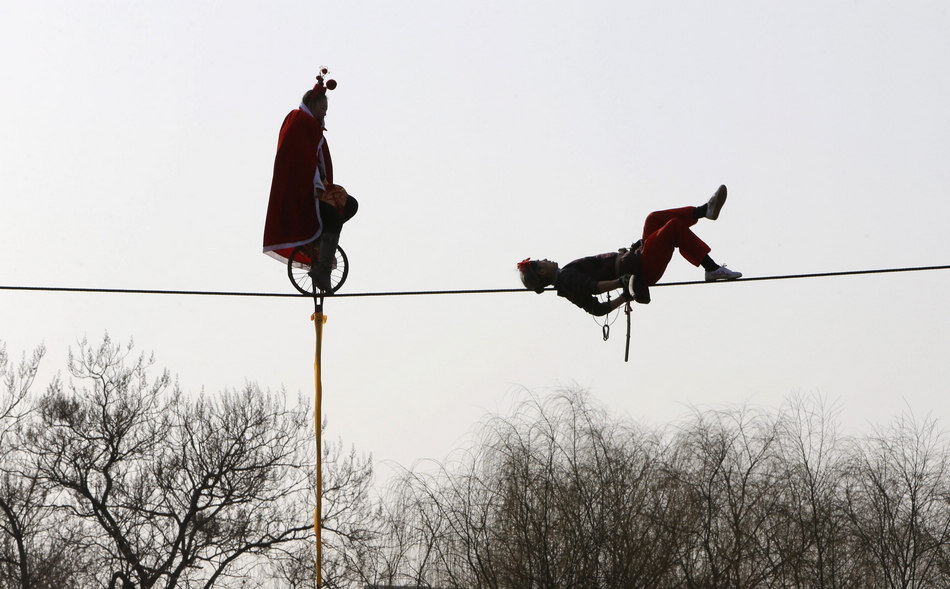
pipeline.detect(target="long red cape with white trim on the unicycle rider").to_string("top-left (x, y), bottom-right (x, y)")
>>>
top-left (264, 108), bottom-right (333, 261)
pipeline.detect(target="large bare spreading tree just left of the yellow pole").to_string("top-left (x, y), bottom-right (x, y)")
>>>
top-left (29, 336), bottom-right (312, 588)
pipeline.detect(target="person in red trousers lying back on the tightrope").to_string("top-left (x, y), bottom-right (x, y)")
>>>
top-left (518, 186), bottom-right (742, 316)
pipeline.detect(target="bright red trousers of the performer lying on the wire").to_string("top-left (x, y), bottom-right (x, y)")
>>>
top-left (640, 207), bottom-right (710, 285)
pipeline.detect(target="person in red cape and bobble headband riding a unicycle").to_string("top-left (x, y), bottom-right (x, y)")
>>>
top-left (264, 68), bottom-right (359, 290)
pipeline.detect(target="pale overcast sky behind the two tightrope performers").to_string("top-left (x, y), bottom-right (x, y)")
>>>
top-left (0, 0), bottom-right (950, 476)
